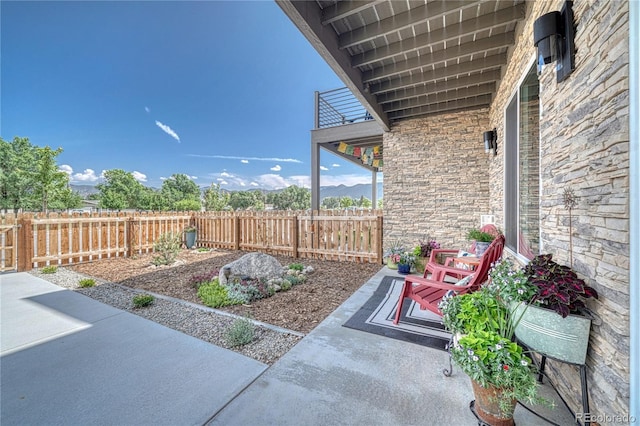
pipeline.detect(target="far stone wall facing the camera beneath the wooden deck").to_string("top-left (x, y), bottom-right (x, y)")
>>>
top-left (383, 108), bottom-right (494, 251)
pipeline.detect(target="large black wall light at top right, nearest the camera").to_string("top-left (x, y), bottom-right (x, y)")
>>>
top-left (533, 1), bottom-right (575, 83)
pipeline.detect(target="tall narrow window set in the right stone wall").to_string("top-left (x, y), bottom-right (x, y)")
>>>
top-left (504, 65), bottom-right (540, 259)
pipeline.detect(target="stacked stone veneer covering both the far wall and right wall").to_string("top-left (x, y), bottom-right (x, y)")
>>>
top-left (384, 0), bottom-right (638, 424)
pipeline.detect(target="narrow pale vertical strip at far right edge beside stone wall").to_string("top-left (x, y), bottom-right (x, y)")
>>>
top-left (629, 1), bottom-right (640, 421)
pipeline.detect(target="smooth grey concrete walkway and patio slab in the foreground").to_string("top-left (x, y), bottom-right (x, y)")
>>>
top-left (0, 268), bottom-right (574, 426)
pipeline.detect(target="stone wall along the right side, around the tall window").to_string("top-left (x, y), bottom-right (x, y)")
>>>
top-left (484, 0), bottom-right (629, 424)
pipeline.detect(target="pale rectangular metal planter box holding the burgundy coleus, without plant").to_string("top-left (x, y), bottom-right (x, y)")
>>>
top-left (513, 303), bottom-right (591, 364)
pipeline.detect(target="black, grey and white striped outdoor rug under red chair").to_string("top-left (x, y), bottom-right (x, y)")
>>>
top-left (343, 276), bottom-right (451, 351)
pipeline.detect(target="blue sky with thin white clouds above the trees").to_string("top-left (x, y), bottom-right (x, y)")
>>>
top-left (0, 1), bottom-right (371, 190)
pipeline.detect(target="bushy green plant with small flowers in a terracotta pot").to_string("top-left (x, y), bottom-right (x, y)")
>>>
top-left (440, 261), bottom-right (551, 426)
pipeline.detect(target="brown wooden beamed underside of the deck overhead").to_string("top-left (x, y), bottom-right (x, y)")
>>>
top-left (276, 0), bottom-right (526, 131)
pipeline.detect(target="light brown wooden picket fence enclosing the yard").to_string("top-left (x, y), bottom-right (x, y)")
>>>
top-left (0, 210), bottom-right (382, 272)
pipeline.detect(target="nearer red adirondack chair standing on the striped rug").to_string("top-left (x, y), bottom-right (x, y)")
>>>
top-left (393, 235), bottom-right (504, 324)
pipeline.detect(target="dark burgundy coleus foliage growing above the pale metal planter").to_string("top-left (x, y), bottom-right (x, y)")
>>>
top-left (524, 254), bottom-right (598, 318)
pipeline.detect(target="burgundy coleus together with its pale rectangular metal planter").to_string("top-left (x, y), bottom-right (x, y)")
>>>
top-left (516, 254), bottom-right (598, 364)
